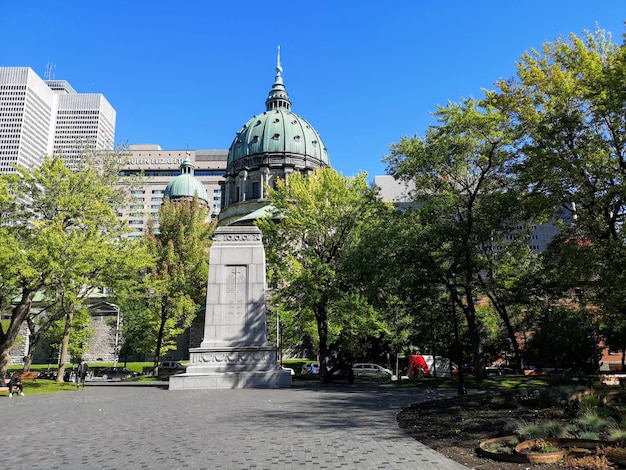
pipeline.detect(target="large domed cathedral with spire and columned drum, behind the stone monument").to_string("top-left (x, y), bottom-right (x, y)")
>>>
top-left (219, 49), bottom-right (330, 225)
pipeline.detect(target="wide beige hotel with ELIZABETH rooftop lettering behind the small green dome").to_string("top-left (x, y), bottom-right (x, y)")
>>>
top-left (118, 145), bottom-right (228, 238)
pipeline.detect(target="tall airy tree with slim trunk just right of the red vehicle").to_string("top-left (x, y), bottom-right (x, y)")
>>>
top-left (385, 99), bottom-right (528, 376)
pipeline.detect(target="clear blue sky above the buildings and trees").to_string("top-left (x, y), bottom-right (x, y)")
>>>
top-left (0, 0), bottom-right (626, 180)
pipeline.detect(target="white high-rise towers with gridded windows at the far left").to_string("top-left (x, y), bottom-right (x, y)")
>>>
top-left (0, 67), bottom-right (115, 173)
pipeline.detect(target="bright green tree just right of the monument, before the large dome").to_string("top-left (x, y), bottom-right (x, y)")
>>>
top-left (257, 168), bottom-right (376, 370)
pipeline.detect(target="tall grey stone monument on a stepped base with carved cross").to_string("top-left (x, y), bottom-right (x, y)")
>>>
top-left (169, 226), bottom-right (291, 390)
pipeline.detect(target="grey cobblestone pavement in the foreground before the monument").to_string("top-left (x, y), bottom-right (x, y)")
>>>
top-left (0, 382), bottom-right (466, 470)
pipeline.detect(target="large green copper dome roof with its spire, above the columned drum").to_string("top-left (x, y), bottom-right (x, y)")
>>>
top-left (228, 50), bottom-right (330, 166)
